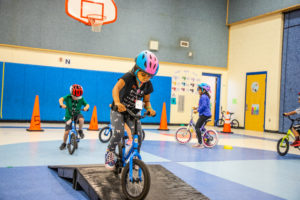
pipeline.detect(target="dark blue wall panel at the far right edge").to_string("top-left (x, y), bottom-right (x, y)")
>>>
top-left (279, 10), bottom-right (300, 132)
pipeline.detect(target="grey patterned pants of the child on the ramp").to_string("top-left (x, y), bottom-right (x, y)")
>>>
top-left (107, 110), bottom-right (142, 151)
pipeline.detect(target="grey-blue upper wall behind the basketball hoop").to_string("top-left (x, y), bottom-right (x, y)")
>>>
top-left (0, 0), bottom-right (228, 67)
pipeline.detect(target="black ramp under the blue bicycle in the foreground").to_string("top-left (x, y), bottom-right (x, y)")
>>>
top-left (49, 165), bottom-right (208, 200)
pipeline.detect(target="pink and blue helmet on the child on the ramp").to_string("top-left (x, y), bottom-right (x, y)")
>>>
top-left (135, 50), bottom-right (159, 76)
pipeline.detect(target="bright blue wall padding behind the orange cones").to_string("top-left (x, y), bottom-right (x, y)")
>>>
top-left (0, 63), bottom-right (171, 123)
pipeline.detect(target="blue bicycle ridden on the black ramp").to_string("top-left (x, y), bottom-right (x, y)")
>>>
top-left (111, 109), bottom-right (151, 200)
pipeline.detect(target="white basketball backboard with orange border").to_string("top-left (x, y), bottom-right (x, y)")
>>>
top-left (65, 0), bottom-right (117, 26)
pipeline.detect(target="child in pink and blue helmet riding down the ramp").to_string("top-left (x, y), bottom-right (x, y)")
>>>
top-left (105, 51), bottom-right (159, 170)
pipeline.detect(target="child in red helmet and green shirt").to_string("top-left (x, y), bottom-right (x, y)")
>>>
top-left (58, 84), bottom-right (90, 150)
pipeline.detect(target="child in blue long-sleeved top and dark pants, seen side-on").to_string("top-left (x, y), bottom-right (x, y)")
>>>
top-left (193, 83), bottom-right (211, 149)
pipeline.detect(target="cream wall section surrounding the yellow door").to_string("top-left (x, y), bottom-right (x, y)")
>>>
top-left (227, 14), bottom-right (284, 131)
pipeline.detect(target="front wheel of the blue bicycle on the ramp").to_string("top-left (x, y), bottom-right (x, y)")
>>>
top-left (121, 159), bottom-right (151, 200)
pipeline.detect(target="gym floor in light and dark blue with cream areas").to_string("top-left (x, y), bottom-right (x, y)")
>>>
top-left (0, 123), bottom-right (300, 200)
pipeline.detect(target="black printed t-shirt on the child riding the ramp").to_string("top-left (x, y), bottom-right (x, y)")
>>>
top-left (113, 72), bottom-right (153, 113)
